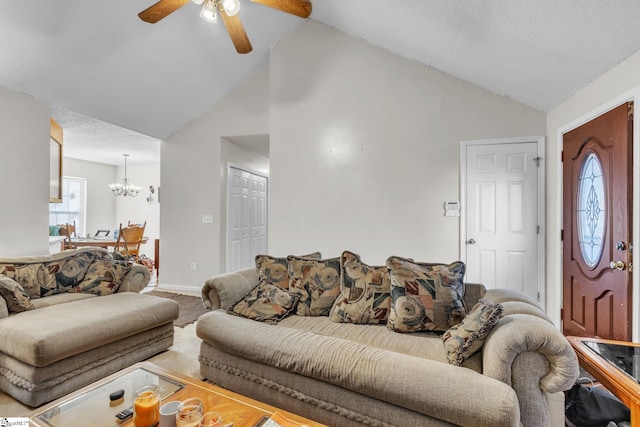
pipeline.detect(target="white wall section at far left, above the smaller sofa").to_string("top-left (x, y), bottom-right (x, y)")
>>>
top-left (0, 87), bottom-right (51, 257)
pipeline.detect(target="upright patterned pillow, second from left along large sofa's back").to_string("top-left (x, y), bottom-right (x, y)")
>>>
top-left (287, 255), bottom-right (340, 316)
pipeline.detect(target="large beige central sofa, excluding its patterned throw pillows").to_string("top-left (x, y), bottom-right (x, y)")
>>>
top-left (197, 268), bottom-right (578, 427)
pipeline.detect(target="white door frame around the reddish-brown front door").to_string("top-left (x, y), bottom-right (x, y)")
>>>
top-left (547, 86), bottom-right (640, 342)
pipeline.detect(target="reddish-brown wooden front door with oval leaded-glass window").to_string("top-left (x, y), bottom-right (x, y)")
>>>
top-left (562, 103), bottom-right (633, 341)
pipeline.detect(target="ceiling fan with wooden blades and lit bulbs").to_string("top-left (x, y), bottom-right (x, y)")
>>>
top-left (138, 0), bottom-right (311, 53)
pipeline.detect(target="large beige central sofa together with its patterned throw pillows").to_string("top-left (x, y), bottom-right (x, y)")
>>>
top-left (196, 251), bottom-right (578, 427)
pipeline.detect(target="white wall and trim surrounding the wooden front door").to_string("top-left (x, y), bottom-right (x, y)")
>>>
top-left (546, 48), bottom-right (640, 332)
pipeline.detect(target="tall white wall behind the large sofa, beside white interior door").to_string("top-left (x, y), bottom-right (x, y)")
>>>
top-left (269, 21), bottom-right (545, 265)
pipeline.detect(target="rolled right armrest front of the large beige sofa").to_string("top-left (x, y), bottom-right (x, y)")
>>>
top-left (482, 312), bottom-right (579, 425)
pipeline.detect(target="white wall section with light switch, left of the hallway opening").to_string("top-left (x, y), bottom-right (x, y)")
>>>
top-left (159, 70), bottom-right (269, 290)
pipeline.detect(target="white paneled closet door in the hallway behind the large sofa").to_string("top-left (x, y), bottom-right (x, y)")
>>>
top-left (227, 167), bottom-right (268, 271)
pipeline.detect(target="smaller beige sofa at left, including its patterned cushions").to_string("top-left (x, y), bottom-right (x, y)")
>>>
top-left (0, 248), bottom-right (178, 407)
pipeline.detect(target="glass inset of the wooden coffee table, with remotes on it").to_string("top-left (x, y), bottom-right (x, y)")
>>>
top-left (31, 368), bottom-right (185, 427)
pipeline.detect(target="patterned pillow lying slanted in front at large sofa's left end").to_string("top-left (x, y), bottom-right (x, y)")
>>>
top-left (228, 281), bottom-right (300, 325)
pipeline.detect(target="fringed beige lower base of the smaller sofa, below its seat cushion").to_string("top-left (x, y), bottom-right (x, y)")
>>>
top-left (0, 322), bottom-right (174, 407)
